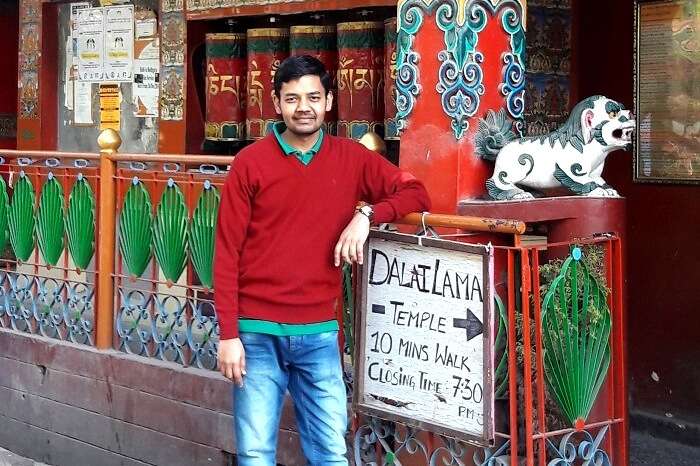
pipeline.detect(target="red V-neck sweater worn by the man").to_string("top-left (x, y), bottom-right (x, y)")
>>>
top-left (214, 135), bottom-right (430, 340)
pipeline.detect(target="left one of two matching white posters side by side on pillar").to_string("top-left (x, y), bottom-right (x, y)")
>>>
top-left (76, 8), bottom-right (104, 82)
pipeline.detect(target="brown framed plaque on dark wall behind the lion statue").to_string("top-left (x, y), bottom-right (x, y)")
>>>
top-left (634, 0), bottom-right (700, 183)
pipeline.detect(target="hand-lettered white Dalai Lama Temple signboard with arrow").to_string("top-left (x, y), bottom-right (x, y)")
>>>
top-left (353, 231), bottom-right (494, 445)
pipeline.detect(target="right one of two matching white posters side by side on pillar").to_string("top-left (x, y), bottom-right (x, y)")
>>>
top-left (104, 5), bottom-right (134, 82)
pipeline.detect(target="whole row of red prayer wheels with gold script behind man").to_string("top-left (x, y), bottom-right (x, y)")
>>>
top-left (205, 18), bottom-right (399, 141)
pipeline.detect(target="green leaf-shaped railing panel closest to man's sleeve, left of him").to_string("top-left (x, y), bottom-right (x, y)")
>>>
top-left (190, 182), bottom-right (221, 288)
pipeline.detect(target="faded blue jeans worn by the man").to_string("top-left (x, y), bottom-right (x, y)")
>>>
top-left (233, 331), bottom-right (348, 466)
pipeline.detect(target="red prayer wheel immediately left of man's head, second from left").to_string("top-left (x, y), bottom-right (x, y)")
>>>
top-left (246, 28), bottom-right (289, 139)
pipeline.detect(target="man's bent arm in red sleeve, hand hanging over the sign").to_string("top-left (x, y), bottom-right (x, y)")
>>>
top-left (334, 146), bottom-right (431, 267)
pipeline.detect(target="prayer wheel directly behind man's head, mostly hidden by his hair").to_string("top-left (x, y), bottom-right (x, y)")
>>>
top-left (289, 26), bottom-right (338, 134)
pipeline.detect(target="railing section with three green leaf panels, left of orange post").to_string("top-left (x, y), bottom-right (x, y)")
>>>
top-left (0, 151), bottom-right (98, 344)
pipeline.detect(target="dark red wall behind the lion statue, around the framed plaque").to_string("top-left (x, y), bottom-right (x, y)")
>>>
top-left (574, 0), bottom-right (700, 422)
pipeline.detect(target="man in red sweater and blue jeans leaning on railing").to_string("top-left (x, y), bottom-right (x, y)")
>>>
top-left (214, 56), bottom-right (430, 466)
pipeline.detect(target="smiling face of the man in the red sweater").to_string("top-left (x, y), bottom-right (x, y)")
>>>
top-left (272, 75), bottom-right (333, 136)
